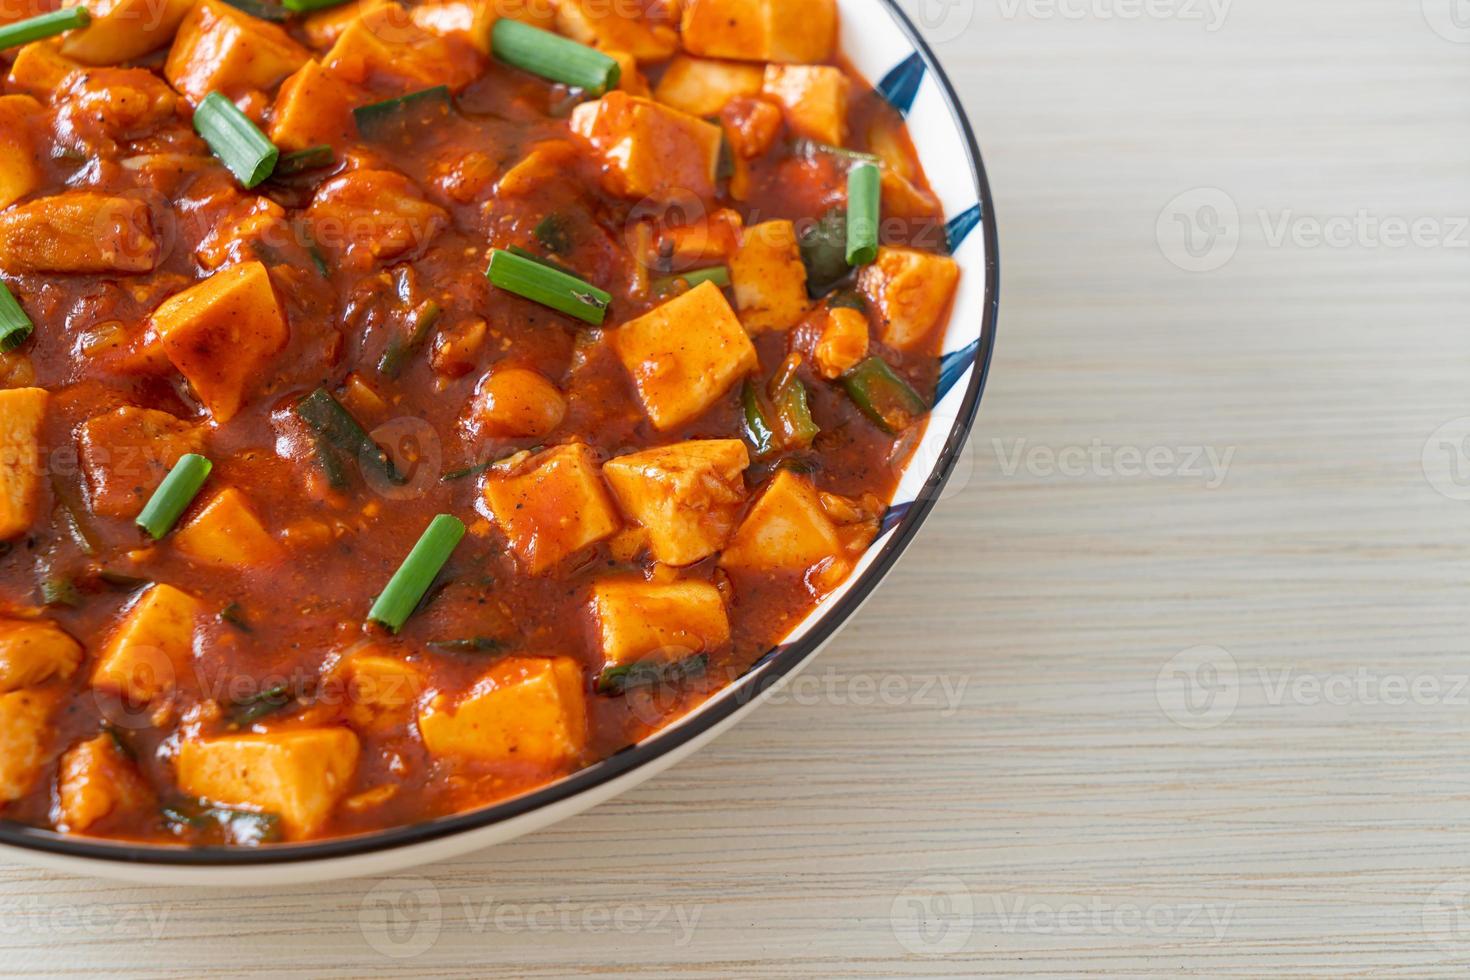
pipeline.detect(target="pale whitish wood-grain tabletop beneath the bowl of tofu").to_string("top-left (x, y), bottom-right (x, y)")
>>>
top-left (0, 0), bottom-right (1470, 977)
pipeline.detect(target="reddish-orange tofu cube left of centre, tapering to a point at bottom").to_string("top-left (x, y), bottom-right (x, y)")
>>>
top-left (151, 262), bottom-right (287, 425)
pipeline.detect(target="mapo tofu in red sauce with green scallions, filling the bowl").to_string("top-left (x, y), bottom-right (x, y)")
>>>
top-left (0, 0), bottom-right (958, 846)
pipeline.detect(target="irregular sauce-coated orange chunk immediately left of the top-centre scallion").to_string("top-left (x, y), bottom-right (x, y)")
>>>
top-left (322, 13), bottom-right (484, 96)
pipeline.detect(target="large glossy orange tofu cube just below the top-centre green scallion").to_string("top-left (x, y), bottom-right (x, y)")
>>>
top-left (572, 91), bottom-right (720, 201)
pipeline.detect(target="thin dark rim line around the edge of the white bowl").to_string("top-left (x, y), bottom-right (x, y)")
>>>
top-left (0, 0), bottom-right (1000, 867)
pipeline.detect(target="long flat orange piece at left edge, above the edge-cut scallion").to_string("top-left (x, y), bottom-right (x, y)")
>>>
top-left (0, 191), bottom-right (159, 272)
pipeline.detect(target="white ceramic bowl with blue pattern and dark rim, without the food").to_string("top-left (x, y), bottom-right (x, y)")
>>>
top-left (0, 0), bottom-right (1000, 886)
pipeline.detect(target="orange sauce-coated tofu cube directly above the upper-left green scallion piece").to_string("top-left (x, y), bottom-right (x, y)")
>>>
top-left (163, 0), bottom-right (310, 104)
